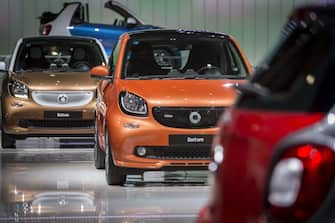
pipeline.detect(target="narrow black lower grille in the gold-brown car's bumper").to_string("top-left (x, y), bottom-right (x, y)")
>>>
top-left (19, 120), bottom-right (95, 128)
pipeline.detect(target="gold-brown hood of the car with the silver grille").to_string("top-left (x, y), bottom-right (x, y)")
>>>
top-left (12, 72), bottom-right (97, 91)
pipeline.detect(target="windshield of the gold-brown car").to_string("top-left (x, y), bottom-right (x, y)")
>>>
top-left (14, 39), bottom-right (103, 72)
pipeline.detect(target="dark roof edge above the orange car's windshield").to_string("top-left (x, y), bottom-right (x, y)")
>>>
top-left (128, 29), bottom-right (230, 39)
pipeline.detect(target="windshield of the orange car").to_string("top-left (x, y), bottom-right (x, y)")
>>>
top-left (124, 36), bottom-right (247, 79)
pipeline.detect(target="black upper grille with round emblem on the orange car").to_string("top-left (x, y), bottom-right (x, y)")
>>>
top-left (152, 107), bottom-right (224, 129)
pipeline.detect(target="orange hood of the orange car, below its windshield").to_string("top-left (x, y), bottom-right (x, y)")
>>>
top-left (119, 80), bottom-right (244, 107)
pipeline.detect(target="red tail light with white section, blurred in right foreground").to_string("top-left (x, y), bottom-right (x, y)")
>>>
top-left (266, 145), bottom-right (335, 222)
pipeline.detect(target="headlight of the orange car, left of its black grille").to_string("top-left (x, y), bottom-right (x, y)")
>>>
top-left (120, 92), bottom-right (148, 116)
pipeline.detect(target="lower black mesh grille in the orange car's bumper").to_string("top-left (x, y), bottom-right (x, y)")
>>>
top-left (135, 146), bottom-right (210, 160)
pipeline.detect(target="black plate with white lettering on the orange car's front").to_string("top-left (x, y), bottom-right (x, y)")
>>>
top-left (169, 135), bottom-right (213, 145)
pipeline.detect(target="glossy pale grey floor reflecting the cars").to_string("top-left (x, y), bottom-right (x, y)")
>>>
top-left (0, 140), bottom-right (209, 223)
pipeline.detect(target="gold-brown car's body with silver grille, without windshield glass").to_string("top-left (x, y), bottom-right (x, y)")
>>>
top-left (2, 37), bottom-right (107, 141)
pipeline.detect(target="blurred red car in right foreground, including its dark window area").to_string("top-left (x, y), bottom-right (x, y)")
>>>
top-left (198, 3), bottom-right (335, 223)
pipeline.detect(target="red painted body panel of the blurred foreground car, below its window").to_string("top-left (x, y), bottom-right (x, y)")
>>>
top-left (213, 111), bottom-right (323, 223)
